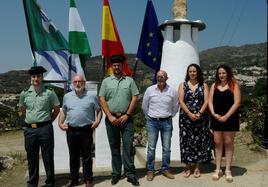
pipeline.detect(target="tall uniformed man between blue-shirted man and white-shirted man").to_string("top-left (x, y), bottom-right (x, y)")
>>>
top-left (99, 55), bottom-right (139, 186)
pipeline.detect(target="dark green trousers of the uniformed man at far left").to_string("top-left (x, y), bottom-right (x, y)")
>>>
top-left (24, 123), bottom-right (55, 187)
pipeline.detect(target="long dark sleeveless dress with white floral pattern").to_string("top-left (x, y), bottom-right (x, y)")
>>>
top-left (179, 82), bottom-right (212, 164)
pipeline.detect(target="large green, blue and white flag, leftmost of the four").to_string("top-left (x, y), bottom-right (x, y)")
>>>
top-left (23, 0), bottom-right (77, 87)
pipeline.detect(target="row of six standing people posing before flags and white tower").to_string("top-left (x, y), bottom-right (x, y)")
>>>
top-left (19, 55), bottom-right (240, 187)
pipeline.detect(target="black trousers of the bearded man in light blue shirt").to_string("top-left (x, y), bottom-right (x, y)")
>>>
top-left (67, 125), bottom-right (93, 182)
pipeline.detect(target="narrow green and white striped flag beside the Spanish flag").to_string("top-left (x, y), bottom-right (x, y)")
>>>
top-left (69, 0), bottom-right (91, 79)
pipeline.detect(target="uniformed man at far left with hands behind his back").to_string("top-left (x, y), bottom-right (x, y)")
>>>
top-left (19, 66), bottom-right (60, 187)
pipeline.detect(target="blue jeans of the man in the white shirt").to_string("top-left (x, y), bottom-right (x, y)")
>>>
top-left (147, 117), bottom-right (173, 172)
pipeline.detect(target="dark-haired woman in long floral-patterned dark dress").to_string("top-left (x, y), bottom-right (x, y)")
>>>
top-left (178, 64), bottom-right (212, 177)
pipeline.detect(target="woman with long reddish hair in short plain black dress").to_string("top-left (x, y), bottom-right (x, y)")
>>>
top-left (209, 64), bottom-right (241, 182)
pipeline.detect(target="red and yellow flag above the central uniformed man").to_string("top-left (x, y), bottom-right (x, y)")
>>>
top-left (102, 0), bottom-right (132, 76)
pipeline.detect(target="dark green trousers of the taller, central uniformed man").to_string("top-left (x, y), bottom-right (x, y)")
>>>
top-left (105, 118), bottom-right (135, 177)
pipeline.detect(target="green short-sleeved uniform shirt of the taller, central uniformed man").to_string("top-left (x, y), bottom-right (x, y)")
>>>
top-left (99, 75), bottom-right (139, 113)
